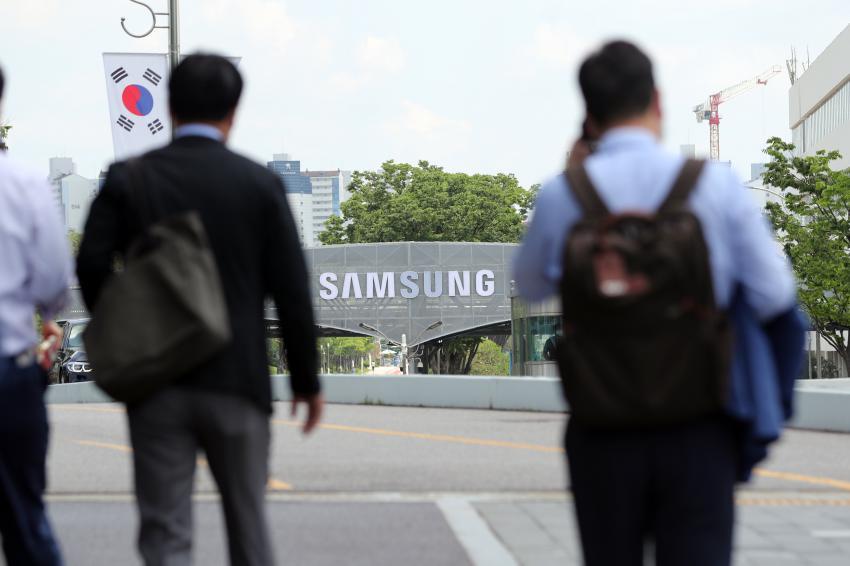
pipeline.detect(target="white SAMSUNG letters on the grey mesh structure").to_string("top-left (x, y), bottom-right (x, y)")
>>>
top-left (319, 269), bottom-right (496, 301)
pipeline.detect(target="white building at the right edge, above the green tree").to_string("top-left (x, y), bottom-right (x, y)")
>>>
top-left (788, 25), bottom-right (850, 169)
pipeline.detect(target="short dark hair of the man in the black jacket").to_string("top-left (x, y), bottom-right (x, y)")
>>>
top-left (168, 53), bottom-right (242, 122)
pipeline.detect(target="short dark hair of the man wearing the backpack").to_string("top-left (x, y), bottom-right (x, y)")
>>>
top-left (578, 41), bottom-right (655, 127)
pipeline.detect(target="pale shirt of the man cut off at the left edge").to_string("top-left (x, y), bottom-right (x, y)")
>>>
top-left (0, 152), bottom-right (71, 357)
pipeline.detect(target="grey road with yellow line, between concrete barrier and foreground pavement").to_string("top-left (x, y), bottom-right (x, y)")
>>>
top-left (48, 404), bottom-right (850, 494)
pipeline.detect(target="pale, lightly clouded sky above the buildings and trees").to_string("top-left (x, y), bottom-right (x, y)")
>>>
top-left (0, 0), bottom-right (850, 186)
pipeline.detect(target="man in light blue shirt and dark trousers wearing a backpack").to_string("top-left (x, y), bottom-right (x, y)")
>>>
top-left (514, 42), bottom-right (796, 566)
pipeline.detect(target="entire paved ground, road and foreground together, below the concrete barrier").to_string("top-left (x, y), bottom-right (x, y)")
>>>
top-left (16, 405), bottom-right (850, 566)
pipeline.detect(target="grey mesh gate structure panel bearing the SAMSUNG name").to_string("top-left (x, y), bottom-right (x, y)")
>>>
top-left (305, 242), bottom-right (517, 344)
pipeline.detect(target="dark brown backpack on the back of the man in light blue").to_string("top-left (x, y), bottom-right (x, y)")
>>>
top-left (557, 160), bottom-right (731, 429)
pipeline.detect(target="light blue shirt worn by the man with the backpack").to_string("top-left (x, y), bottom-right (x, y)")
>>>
top-left (514, 128), bottom-right (796, 320)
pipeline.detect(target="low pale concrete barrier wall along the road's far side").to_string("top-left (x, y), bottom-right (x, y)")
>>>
top-left (47, 375), bottom-right (850, 432)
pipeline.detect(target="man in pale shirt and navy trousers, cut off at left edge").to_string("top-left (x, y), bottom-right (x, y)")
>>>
top-left (0, 65), bottom-right (71, 566)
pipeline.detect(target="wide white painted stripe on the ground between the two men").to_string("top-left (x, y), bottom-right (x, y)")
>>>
top-left (437, 497), bottom-right (517, 566)
